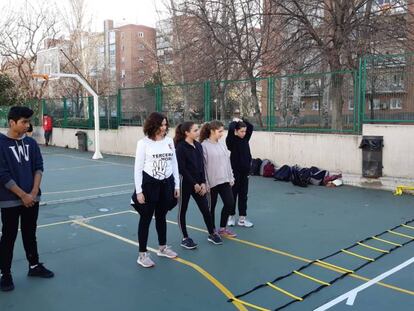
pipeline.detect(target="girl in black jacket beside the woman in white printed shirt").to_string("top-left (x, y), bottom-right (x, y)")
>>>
top-left (174, 122), bottom-right (222, 249)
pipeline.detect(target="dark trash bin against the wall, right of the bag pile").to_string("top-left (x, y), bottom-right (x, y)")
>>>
top-left (359, 136), bottom-right (384, 178)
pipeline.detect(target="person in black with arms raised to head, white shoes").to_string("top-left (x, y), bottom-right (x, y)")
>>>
top-left (226, 119), bottom-right (253, 228)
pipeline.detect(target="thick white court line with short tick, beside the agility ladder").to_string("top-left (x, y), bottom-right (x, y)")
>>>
top-left (314, 257), bottom-right (414, 311)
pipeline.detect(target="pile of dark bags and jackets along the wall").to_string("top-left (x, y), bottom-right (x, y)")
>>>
top-left (250, 158), bottom-right (343, 187)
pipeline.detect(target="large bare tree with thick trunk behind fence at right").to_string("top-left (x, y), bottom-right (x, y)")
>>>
top-left (266, 0), bottom-right (412, 130)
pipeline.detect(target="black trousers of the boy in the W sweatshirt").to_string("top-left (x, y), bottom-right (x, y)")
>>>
top-left (0, 203), bottom-right (39, 273)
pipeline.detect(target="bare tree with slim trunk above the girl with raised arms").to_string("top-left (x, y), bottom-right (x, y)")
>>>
top-left (173, 0), bottom-right (271, 124)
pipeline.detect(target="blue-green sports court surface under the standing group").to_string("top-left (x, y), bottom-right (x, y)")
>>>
top-left (0, 148), bottom-right (414, 311)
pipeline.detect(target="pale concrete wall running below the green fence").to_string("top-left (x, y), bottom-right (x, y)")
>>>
top-left (2, 124), bottom-right (414, 179)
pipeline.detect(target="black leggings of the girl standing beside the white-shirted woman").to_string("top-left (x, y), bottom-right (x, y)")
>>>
top-left (178, 184), bottom-right (214, 238)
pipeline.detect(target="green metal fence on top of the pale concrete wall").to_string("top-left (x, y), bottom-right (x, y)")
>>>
top-left (17, 54), bottom-right (414, 133)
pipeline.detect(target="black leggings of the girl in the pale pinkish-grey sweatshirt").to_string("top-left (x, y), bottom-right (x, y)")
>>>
top-left (210, 183), bottom-right (234, 228)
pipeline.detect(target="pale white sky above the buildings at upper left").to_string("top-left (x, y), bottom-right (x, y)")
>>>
top-left (0, 0), bottom-right (166, 32)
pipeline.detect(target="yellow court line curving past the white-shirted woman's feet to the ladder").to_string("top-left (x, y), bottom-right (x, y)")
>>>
top-left (73, 220), bottom-right (248, 311)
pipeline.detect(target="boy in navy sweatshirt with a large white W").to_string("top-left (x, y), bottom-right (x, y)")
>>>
top-left (0, 107), bottom-right (54, 291)
